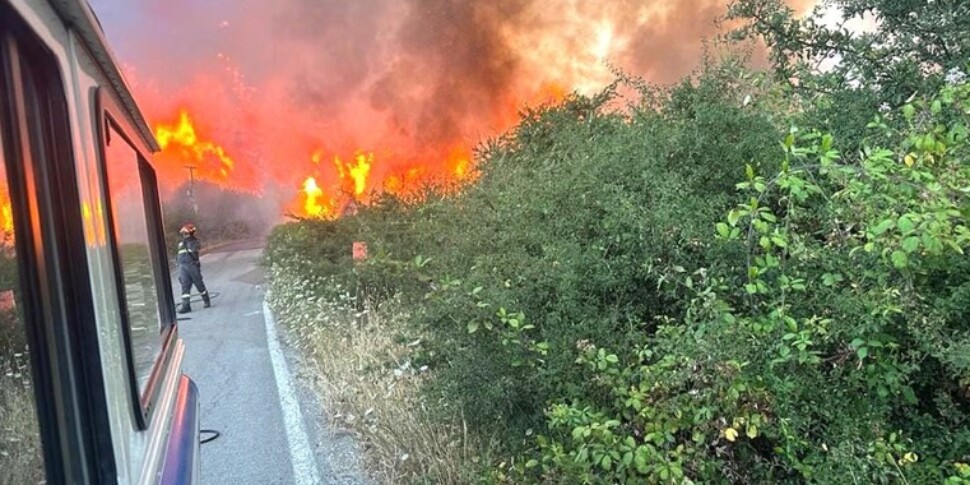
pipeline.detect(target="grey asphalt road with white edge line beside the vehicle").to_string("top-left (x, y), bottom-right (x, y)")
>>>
top-left (173, 242), bottom-right (366, 485)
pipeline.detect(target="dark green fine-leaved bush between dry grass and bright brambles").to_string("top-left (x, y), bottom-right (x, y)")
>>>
top-left (404, 64), bottom-right (780, 434)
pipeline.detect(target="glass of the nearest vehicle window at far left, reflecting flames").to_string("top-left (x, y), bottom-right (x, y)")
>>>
top-left (0, 130), bottom-right (44, 483)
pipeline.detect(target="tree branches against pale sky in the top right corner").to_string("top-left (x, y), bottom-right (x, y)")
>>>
top-left (728, 0), bottom-right (970, 103)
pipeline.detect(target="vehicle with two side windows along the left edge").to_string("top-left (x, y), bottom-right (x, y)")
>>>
top-left (0, 0), bottom-right (199, 484)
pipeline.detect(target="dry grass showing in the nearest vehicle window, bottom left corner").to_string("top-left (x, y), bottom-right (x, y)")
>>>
top-left (0, 352), bottom-right (45, 485)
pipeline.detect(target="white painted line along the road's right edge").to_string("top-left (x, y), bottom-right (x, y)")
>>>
top-left (263, 300), bottom-right (321, 485)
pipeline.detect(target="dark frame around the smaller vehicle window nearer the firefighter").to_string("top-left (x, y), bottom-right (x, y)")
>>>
top-left (94, 87), bottom-right (178, 430)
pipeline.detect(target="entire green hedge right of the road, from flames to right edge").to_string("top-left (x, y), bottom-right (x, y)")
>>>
top-left (267, 52), bottom-right (970, 483)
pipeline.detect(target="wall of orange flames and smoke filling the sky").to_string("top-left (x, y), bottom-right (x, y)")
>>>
top-left (92, 0), bottom-right (811, 217)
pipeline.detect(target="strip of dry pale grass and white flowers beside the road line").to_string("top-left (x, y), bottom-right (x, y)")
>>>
top-left (269, 265), bottom-right (482, 484)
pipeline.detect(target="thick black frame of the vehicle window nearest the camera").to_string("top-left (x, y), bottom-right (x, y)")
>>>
top-left (0, 2), bottom-right (117, 483)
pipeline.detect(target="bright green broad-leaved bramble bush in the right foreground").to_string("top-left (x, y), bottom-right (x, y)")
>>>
top-left (520, 80), bottom-right (970, 483)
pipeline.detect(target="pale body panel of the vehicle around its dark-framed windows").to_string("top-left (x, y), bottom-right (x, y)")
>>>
top-left (0, 0), bottom-right (198, 483)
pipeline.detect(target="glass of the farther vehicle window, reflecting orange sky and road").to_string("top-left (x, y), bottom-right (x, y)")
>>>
top-left (105, 124), bottom-right (162, 394)
